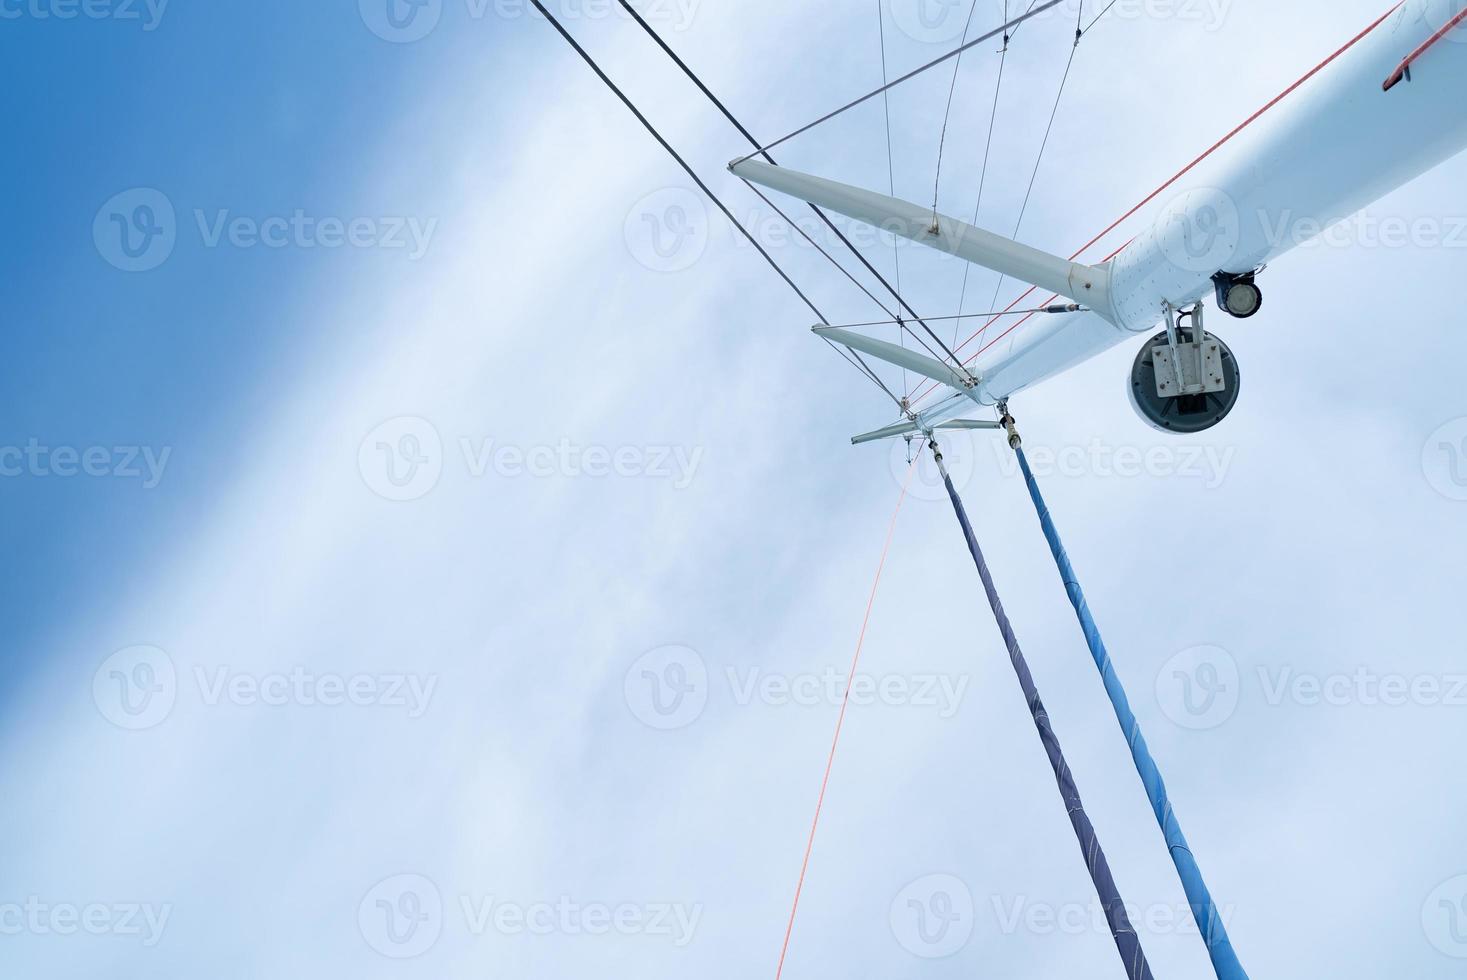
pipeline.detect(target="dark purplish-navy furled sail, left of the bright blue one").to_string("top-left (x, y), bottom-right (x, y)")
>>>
top-left (937, 456), bottom-right (1152, 980)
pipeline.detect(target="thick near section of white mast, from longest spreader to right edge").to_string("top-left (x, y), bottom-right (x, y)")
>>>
top-left (1112, 0), bottom-right (1467, 332)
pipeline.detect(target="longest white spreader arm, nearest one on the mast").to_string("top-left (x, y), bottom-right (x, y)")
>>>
top-left (729, 160), bottom-right (1111, 318)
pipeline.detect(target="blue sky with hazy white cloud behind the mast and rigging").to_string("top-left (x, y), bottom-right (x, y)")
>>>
top-left (0, 0), bottom-right (1467, 979)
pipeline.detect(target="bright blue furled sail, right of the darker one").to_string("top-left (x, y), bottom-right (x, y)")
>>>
top-left (1015, 447), bottom-right (1248, 980)
